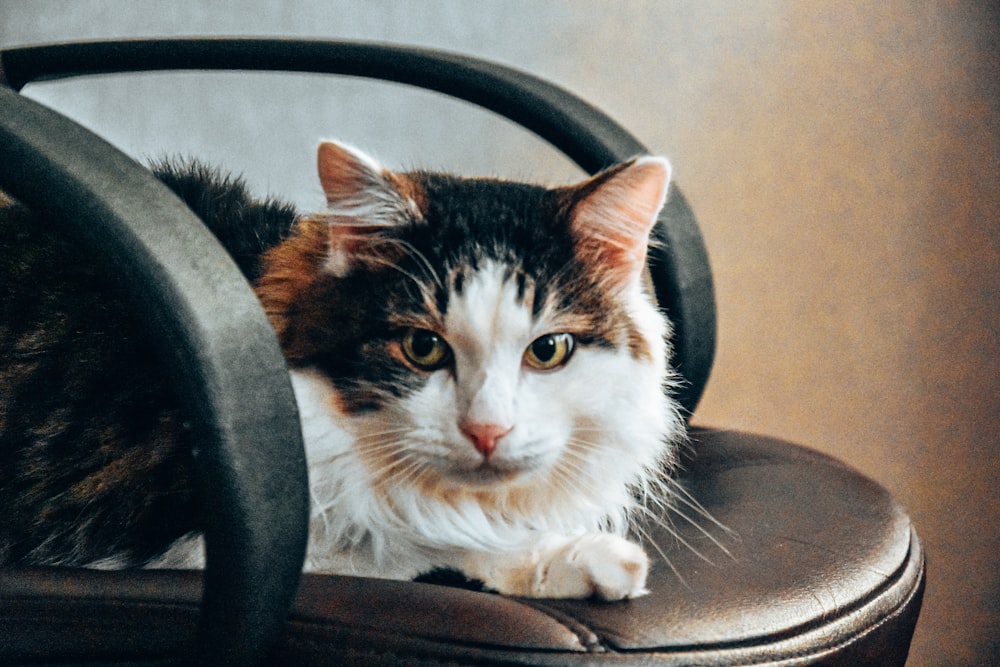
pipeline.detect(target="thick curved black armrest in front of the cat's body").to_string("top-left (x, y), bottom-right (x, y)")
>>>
top-left (0, 86), bottom-right (309, 665)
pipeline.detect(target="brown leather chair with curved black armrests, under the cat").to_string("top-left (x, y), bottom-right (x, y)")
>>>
top-left (0, 39), bottom-right (924, 665)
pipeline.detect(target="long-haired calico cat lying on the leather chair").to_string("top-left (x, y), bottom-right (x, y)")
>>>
top-left (0, 142), bottom-right (683, 600)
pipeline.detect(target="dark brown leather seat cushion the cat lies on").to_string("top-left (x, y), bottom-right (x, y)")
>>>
top-left (0, 429), bottom-right (924, 665)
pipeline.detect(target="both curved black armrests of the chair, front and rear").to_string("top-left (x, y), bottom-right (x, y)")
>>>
top-left (0, 39), bottom-right (715, 664)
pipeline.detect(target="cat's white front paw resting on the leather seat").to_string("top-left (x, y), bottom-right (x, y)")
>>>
top-left (531, 533), bottom-right (649, 600)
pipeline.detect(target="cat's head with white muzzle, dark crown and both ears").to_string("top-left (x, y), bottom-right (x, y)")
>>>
top-left (258, 143), bottom-right (679, 520)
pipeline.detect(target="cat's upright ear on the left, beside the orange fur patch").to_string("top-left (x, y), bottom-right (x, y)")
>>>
top-left (316, 141), bottom-right (420, 277)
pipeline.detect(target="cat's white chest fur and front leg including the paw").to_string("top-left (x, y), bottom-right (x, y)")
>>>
top-left (292, 360), bottom-right (664, 600)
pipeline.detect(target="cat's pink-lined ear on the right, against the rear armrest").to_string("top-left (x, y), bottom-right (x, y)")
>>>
top-left (568, 157), bottom-right (670, 285)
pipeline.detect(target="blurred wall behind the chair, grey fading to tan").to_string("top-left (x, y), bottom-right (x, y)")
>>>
top-left (0, 0), bottom-right (1000, 665)
